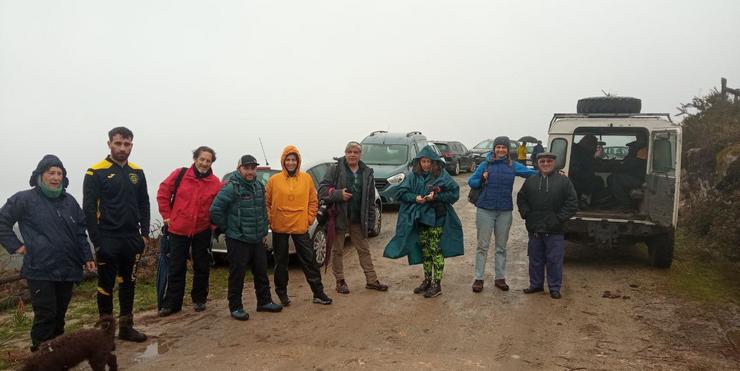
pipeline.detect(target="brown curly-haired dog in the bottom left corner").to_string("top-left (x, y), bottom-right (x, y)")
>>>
top-left (22, 315), bottom-right (118, 371)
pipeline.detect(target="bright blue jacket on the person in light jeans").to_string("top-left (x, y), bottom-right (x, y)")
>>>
top-left (468, 152), bottom-right (535, 211)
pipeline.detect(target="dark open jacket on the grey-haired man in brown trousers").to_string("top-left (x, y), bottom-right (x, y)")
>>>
top-left (318, 157), bottom-right (377, 237)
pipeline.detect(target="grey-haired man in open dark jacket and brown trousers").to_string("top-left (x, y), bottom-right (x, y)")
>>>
top-left (319, 142), bottom-right (388, 294)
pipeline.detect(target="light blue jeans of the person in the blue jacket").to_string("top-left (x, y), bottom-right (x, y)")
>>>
top-left (475, 207), bottom-right (511, 280)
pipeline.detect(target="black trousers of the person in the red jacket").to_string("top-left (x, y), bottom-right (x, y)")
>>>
top-left (163, 228), bottom-right (211, 311)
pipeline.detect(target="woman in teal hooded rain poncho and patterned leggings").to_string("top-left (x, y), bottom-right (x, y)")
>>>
top-left (383, 146), bottom-right (464, 298)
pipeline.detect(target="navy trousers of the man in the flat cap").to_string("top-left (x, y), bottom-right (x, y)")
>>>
top-left (527, 232), bottom-right (565, 292)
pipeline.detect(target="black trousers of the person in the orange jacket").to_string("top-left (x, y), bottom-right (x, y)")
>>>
top-left (272, 232), bottom-right (324, 295)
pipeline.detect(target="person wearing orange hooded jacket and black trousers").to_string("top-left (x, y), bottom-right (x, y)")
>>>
top-left (265, 145), bottom-right (331, 306)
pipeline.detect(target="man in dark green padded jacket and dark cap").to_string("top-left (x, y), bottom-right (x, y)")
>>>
top-left (210, 155), bottom-right (283, 321)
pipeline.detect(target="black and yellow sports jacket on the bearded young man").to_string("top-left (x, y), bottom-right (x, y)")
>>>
top-left (82, 157), bottom-right (150, 248)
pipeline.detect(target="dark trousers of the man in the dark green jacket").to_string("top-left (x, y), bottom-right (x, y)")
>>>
top-left (226, 237), bottom-right (272, 312)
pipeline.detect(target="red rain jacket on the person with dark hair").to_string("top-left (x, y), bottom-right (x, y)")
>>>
top-left (157, 166), bottom-right (221, 237)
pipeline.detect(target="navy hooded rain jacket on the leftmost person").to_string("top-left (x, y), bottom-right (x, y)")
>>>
top-left (0, 155), bottom-right (93, 282)
